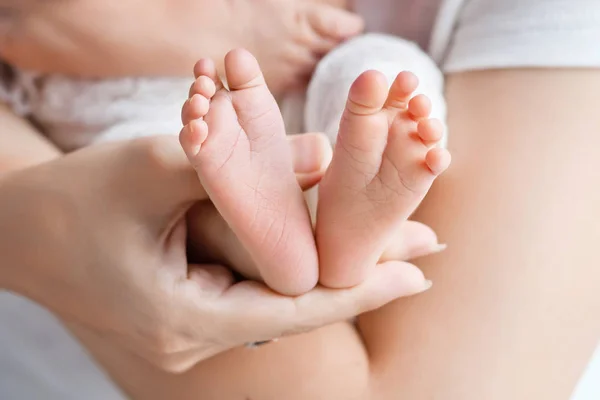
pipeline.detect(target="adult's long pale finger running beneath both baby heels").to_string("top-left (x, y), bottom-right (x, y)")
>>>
top-left (218, 261), bottom-right (431, 344)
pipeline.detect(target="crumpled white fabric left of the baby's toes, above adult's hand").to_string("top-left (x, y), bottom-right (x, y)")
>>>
top-left (0, 71), bottom-right (193, 151)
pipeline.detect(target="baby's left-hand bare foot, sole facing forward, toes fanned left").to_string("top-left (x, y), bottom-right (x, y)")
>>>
top-left (180, 50), bottom-right (318, 295)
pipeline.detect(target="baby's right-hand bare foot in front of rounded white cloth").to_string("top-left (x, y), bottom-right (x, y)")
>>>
top-left (316, 71), bottom-right (450, 287)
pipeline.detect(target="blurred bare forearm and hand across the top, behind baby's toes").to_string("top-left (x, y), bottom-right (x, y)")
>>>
top-left (0, 0), bottom-right (363, 94)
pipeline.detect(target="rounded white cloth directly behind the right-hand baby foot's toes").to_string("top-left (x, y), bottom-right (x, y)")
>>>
top-left (304, 33), bottom-right (446, 144)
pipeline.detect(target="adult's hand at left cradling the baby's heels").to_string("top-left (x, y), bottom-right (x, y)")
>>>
top-left (0, 136), bottom-right (426, 371)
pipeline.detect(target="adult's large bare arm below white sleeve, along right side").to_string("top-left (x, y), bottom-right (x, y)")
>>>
top-left (359, 70), bottom-right (600, 400)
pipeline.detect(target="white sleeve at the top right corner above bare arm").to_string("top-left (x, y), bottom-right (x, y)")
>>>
top-left (436, 0), bottom-right (600, 72)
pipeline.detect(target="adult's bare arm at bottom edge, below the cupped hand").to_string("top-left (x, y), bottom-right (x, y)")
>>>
top-left (75, 323), bottom-right (369, 400)
